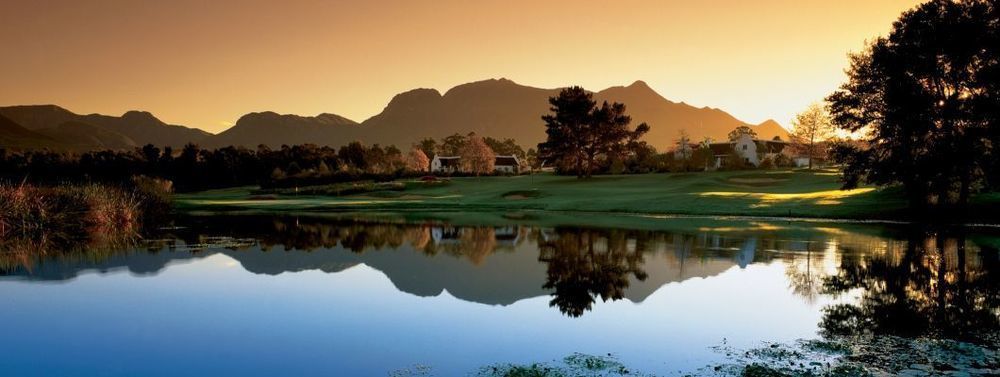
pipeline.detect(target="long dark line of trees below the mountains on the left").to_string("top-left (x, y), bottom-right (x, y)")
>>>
top-left (0, 135), bottom-right (528, 191)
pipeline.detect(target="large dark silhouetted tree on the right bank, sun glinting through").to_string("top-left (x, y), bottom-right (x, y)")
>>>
top-left (827, 0), bottom-right (1000, 209)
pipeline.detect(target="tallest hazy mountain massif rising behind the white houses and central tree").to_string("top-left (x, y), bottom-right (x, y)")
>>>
top-left (359, 79), bottom-right (788, 150)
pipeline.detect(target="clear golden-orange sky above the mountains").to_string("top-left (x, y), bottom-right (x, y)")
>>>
top-left (0, 0), bottom-right (919, 132)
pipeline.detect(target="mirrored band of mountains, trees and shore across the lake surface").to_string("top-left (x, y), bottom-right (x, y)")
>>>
top-left (0, 213), bottom-right (1000, 338)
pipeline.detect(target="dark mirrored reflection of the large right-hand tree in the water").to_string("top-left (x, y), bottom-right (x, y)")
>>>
top-left (820, 229), bottom-right (1000, 341)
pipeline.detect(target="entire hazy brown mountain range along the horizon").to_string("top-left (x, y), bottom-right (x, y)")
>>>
top-left (0, 79), bottom-right (788, 150)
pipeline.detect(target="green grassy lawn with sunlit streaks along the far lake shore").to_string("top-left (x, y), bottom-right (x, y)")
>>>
top-left (175, 170), bottom-right (940, 219)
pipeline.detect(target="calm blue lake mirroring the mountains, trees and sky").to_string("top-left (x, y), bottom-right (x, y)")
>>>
top-left (0, 216), bottom-right (1000, 376)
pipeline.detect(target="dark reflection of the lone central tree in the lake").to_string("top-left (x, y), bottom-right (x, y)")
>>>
top-left (538, 228), bottom-right (647, 317)
